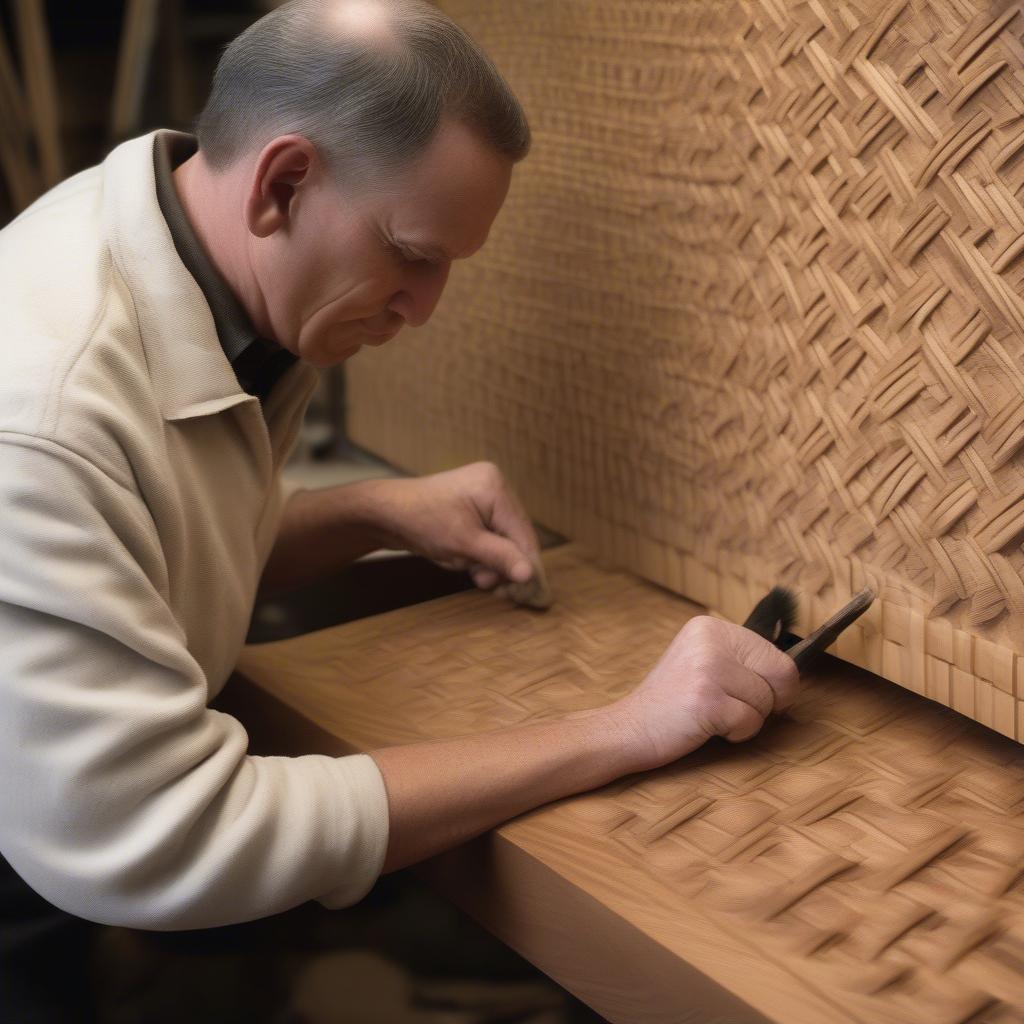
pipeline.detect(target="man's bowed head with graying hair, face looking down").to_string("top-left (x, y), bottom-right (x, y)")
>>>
top-left (182, 0), bottom-right (529, 366)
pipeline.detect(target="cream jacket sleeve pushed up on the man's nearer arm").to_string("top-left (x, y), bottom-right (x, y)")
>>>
top-left (0, 435), bottom-right (388, 930)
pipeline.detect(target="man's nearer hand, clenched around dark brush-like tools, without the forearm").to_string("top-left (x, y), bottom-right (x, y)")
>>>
top-left (607, 615), bottom-right (800, 771)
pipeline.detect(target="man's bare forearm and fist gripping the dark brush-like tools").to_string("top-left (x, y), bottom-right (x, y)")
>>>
top-left (370, 615), bottom-right (799, 871)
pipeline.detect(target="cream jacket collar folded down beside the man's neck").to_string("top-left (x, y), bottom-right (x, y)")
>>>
top-left (102, 130), bottom-right (257, 420)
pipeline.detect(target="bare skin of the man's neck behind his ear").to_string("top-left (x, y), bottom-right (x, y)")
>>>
top-left (173, 153), bottom-right (273, 339)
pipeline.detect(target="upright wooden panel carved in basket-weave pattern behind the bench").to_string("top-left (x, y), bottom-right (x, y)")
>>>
top-left (350, 0), bottom-right (1024, 738)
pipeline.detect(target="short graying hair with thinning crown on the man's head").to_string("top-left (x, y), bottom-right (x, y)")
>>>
top-left (196, 0), bottom-right (530, 184)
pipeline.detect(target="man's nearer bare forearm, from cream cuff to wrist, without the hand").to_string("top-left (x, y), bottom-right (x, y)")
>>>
top-left (371, 709), bottom-right (646, 872)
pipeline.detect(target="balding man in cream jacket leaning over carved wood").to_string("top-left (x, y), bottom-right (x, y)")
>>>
top-left (0, 0), bottom-right (798, 1015)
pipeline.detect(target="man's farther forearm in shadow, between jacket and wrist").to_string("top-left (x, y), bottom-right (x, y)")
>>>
top-left (260, 480), bottom-right (391, 594)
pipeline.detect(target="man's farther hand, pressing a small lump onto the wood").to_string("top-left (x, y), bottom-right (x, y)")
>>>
top-left (374, 462), bottom-right (540, 590)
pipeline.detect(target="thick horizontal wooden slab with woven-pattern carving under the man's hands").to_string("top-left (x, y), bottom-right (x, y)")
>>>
top-left (234, 546), bottom-right (1024, 1024)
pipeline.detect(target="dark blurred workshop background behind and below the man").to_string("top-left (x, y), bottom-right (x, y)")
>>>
top-left (0, 0), bottom-right (589, 1024)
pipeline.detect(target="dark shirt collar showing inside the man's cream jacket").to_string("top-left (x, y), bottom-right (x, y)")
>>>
top-left (153, 131), bottom-right (296, 398)
